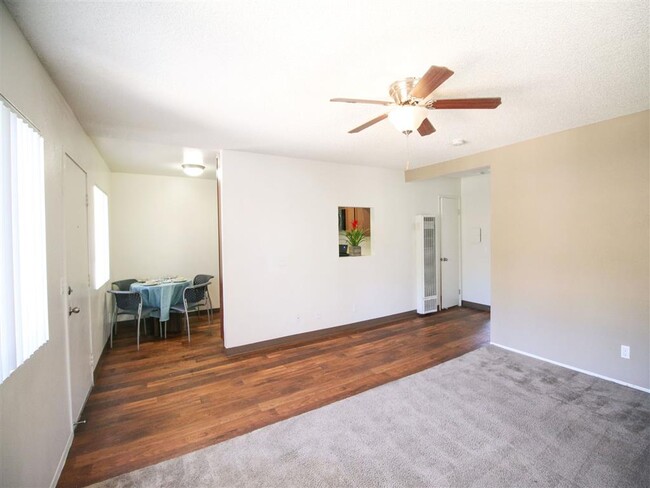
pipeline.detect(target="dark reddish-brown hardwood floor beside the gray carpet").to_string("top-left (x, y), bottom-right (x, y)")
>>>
top-left (58, 308), bottom-right (490, 487)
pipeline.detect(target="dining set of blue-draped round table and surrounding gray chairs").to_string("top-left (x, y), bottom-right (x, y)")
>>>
top-left (107, 274), bottom-right (214, 350)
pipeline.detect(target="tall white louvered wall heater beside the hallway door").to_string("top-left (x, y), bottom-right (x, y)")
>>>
top-left (415, 215), bottom-right (438, 314)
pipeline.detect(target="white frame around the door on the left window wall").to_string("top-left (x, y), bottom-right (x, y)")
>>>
top-left (60, 151), bottom-right (95, 429)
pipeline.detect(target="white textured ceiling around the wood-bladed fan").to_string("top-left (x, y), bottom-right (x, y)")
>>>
top-left (5, 0), bottom-right (650, 175)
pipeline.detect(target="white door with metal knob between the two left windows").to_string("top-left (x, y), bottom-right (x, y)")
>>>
top-left (63, 155), bottom-right (93, 422)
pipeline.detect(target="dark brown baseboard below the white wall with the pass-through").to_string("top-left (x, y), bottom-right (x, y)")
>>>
top-left (225, 310), bottom-right (419, 356)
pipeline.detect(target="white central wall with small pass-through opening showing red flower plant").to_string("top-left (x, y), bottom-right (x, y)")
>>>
top-left (221, 151), bottom-right (460, 347)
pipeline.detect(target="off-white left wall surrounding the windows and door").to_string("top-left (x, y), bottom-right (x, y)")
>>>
top-left (0, 2), bottom-right (110, 487)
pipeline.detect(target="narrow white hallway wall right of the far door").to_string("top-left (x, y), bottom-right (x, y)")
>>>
top-left (460, 174), bottom-right (491, 305)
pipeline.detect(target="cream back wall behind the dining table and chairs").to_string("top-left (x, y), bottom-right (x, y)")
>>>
top-left (109, 173), bottom-right (219, 307)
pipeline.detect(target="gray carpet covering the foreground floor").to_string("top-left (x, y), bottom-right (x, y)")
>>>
top-left (95, 346), bottom-right (650, 488)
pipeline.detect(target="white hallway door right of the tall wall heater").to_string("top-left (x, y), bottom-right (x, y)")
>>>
top-left (440, 197), bottom-right (460, 309)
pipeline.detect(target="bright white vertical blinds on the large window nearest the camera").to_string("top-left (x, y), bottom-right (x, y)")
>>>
top-left (0, 98), bottom-right (49, 382)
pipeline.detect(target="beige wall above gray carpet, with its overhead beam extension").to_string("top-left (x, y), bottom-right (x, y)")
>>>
top-left (407, 111), bottom-right (650, 388)
